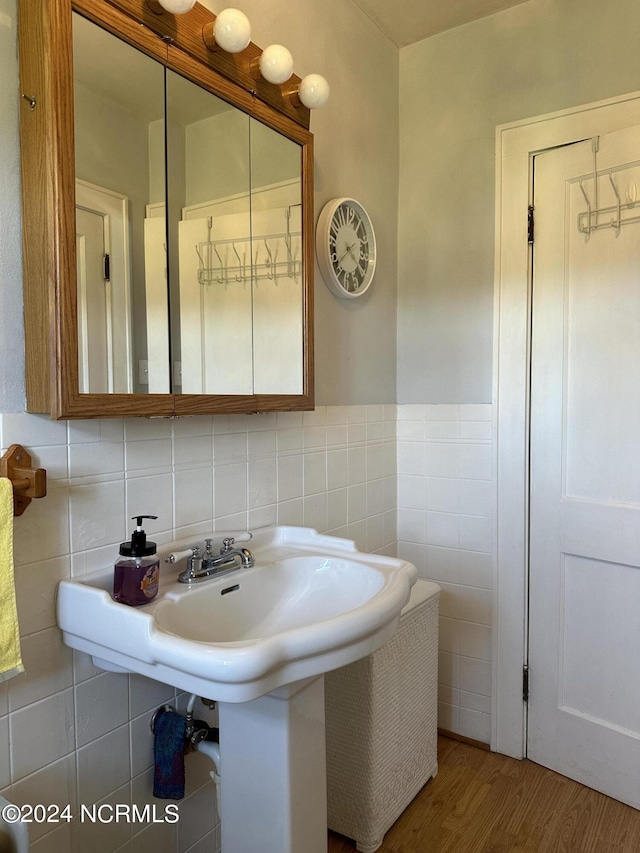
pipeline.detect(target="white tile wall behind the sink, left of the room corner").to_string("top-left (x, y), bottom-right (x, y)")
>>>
top-left (0, 406), bottom-right (398, 853)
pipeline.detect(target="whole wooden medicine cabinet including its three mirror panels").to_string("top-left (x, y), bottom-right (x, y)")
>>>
top-left (19, 0), bottom-right (313, 419)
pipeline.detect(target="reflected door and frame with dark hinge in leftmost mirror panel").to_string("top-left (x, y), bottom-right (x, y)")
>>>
top-left (76, 180), bottom-right (132, 394)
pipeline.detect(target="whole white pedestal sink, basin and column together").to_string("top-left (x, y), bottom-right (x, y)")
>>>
top-left (58, 527), bottom-right (417, 853)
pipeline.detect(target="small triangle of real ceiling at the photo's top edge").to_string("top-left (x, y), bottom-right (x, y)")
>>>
top-left (354, 0), bottom-right (527, 47)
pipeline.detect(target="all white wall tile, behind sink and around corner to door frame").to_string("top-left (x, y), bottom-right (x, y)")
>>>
top-left (0, 405), bottom-right (492, 853)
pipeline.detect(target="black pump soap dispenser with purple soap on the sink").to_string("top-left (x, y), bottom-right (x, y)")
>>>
top-left (113, 515), bottom-right (160, 607)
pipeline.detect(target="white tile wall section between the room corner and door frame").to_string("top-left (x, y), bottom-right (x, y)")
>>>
top-left (398, 405), bottom-right (493, 743)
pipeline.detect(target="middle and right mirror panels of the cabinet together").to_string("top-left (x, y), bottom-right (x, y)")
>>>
top-left (167, 71), bottom-right (303, 394)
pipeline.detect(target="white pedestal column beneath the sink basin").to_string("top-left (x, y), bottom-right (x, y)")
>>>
top-left (219, 676), bottom-right (327, 853)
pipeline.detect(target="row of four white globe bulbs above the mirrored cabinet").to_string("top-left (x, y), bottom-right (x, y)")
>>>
top-left (146, 0), bottom-right (330, 110)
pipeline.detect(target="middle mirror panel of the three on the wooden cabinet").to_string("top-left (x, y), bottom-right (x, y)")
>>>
top-left (167, 71), bottom-right (253, 395)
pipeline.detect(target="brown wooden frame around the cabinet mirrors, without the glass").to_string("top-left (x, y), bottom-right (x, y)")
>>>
top-left (18, 0), bottom-right (314, 419)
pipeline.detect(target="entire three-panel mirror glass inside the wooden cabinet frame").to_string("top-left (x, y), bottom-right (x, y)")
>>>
top-left (73, 14), bottom-right (303, 395)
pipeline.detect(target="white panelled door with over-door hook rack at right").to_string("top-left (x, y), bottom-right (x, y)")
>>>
top-left (527, 128), bottom-right (640, 808)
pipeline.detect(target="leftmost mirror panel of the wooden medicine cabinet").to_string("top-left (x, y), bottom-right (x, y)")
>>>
top-left (73, 14), bottom-right (170, 393)
